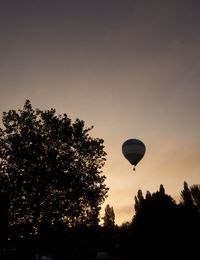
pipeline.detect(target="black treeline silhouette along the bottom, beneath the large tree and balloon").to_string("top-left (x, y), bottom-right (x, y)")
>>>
top-left (0, 182), bottom-right (200, 260)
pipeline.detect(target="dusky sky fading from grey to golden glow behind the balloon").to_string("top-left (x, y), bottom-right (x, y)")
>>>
top-left (0, 0), bottom-right (200, 225)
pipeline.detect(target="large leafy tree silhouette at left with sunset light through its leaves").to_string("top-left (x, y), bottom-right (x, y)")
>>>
top-left (0, 100), bottom-right (108, 234)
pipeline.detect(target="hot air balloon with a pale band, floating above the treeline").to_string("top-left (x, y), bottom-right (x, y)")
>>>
top-left (122, 139), bottom-right (146, 171)
